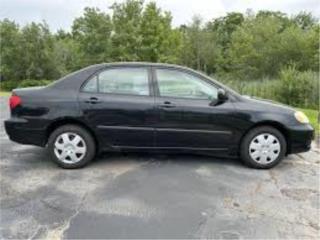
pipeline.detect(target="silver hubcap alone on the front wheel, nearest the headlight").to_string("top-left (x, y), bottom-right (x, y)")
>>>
top-left (249, 133), bottom-right (281, 164)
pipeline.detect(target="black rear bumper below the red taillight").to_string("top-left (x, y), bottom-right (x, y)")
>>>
top-left (4, 118), bottom-right (46, 147)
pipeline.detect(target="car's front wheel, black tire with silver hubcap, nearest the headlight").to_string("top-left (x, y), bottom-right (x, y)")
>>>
top-left (240, 126), bottom-right (287, 169)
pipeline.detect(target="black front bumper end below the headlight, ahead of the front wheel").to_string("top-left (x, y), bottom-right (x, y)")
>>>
top-left (288, 124), bottom-right (314, 154)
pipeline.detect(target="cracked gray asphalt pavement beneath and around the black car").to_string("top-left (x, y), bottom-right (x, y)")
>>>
top-left (0, 98), bottom-right (320, 239)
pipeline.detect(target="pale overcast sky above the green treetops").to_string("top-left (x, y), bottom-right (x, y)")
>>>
top-left (0, 0), bottom-right (320, 31)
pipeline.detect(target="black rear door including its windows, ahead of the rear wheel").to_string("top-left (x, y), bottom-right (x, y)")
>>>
top-left (79, 67), bottom-right (155, 148)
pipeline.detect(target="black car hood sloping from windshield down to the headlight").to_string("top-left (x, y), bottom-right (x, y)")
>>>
top-left (242, 96), bottom-right (296, 113)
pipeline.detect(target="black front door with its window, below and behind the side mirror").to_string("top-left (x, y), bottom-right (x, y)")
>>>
top-left (153, 68), bottom-right (233, 151)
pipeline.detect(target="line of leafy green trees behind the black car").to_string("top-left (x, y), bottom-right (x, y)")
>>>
top-left (0, 0), bottom-right (320, 108)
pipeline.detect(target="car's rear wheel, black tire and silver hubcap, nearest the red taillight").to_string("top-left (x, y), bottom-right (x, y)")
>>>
top-left (48, 124), bottom-right (96, 169)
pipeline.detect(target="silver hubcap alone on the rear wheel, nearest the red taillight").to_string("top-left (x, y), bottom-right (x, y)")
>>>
top-left (54, 132), bottom-right (87, 163)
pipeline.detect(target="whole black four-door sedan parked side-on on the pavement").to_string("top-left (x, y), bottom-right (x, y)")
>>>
top-left (5, 63), bottom-right (314, 168)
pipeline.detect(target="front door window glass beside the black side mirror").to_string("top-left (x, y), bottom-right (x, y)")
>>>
top-left (156, 69), bottom-right (218, 100)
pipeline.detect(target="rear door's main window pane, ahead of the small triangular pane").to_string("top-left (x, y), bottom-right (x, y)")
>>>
top-left (98, 68), bottom-right (149, 95)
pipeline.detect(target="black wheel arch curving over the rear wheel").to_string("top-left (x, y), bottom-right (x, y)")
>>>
top-left (46, 117), bottom-right (99, 150)
